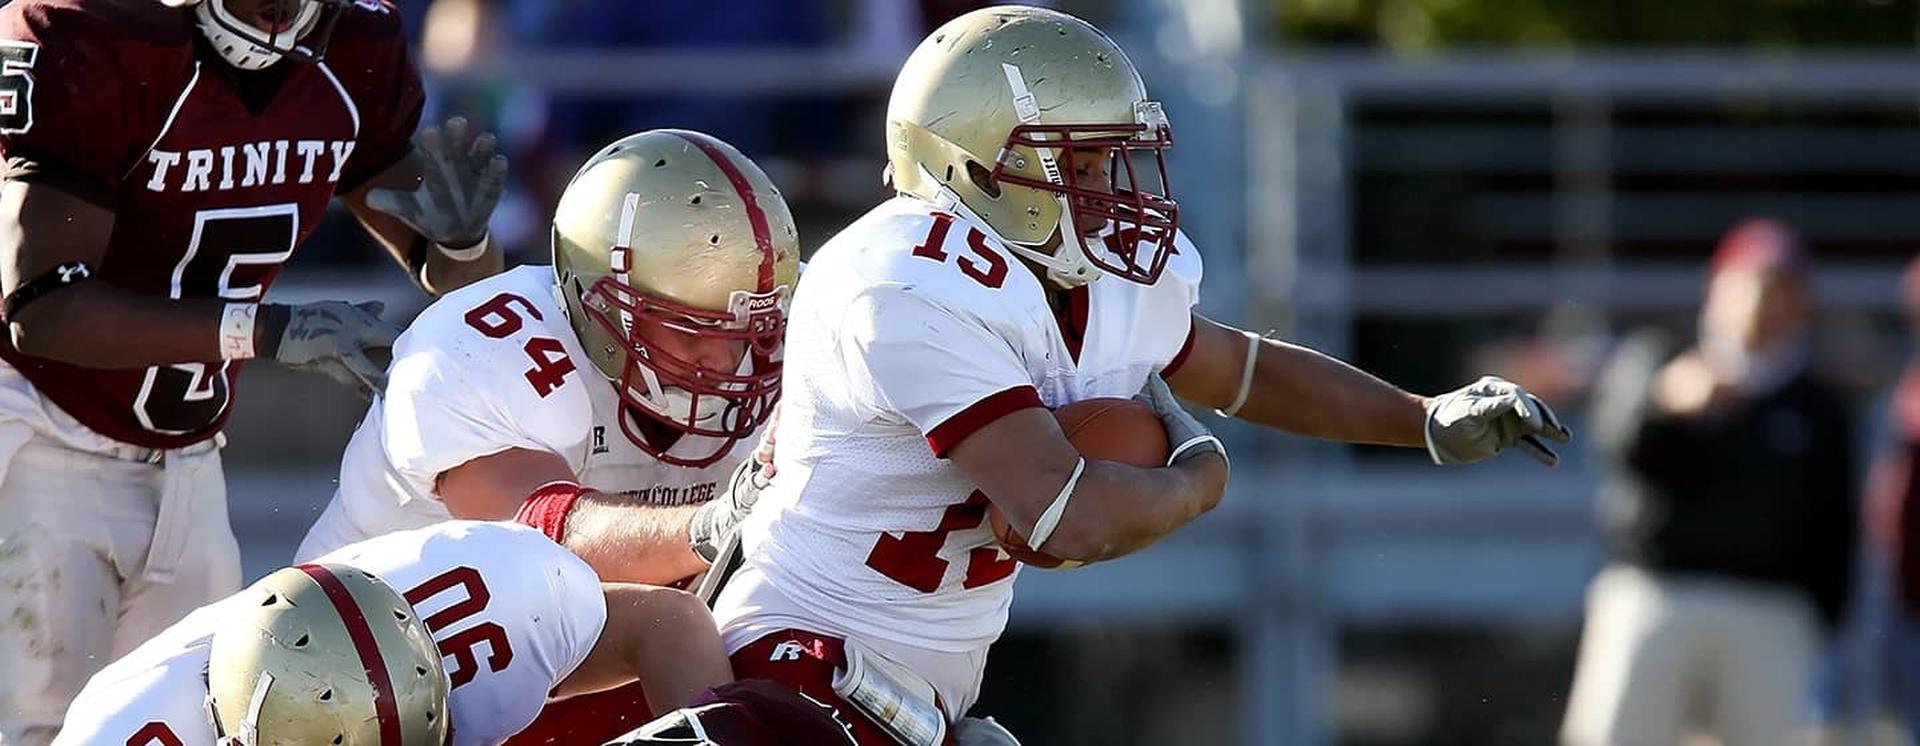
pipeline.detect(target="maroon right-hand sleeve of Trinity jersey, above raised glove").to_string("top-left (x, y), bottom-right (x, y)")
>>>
top-left (326, 0), bottom-right (426, 194)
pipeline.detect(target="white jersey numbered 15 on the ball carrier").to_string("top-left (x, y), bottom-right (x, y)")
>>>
top-left (714, 198), bottom-right (1200, 713)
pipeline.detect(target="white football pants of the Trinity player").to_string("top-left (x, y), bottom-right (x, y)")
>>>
top-left (0, 356), bottom-right (240, 746)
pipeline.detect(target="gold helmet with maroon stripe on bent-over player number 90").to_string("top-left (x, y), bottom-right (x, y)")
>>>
top-left (207, 564), bottom-right (449, 746)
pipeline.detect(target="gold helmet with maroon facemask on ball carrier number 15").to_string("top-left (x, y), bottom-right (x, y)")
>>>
top-left (887, 6), bottom-right (1179, 288)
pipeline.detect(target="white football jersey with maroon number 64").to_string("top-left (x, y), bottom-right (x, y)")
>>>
top-left (298, 267), bottom-right (756, 560)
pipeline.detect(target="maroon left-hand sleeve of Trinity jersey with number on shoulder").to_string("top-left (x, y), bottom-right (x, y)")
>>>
top-left (0, 0), bottom-right (192, 205)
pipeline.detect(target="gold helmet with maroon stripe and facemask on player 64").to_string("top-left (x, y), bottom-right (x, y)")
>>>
top-left (553, 130), bottom-right (801, 466)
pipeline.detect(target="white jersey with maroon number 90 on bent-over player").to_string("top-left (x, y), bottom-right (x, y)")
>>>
top-left (58, 522), bottom-right (607, 746)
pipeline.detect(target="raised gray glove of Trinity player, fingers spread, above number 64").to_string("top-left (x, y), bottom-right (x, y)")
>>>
top-left (367, 117), bottom-right (507, 249)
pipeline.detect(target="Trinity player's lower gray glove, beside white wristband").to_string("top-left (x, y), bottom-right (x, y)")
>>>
top-left (259, 301), bottom-right (403, 395)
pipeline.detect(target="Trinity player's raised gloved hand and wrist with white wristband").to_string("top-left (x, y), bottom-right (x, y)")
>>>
top-left (342, 117), bottom-right (507, 295)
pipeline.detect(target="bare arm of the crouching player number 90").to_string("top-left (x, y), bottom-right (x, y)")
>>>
top-left (553, 583), bottom-right (733, 711)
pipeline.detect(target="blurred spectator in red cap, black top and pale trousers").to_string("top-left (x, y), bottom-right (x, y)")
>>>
top-left (1561, 221), bottom-right (1855, 746)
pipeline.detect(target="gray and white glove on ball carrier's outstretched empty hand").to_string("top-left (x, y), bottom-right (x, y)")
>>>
top-left (1427, 376), bottom-right (1572, 466)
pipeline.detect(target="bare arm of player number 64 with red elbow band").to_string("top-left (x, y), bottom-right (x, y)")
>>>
top-left (436, 449), bottom-right (707, 585)
